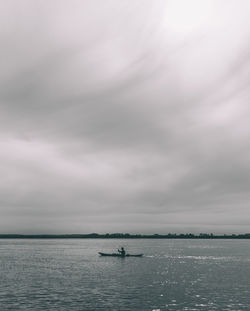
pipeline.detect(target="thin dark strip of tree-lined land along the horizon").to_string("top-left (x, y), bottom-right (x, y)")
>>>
top-left (0, 233), bottom-right (250, 239)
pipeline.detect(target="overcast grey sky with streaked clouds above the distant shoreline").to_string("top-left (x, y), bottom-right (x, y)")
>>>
top-left (0, 0), bottom-right (250, 234)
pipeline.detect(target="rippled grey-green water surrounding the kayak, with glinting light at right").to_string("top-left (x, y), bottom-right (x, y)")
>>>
top-left (0, 239), bottom-right (250, 311)
